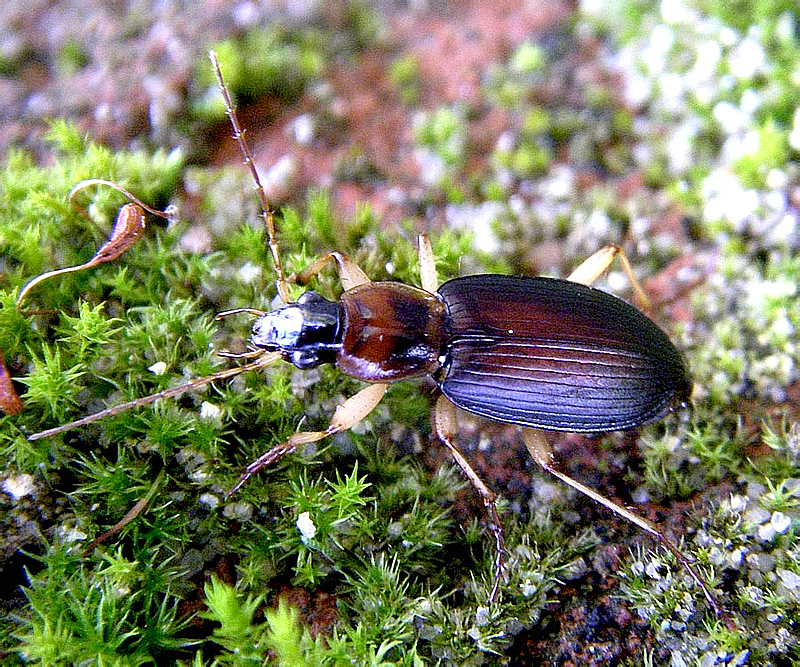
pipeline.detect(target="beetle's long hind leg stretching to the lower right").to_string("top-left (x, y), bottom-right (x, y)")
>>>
top-left (522, 428), bottom-right (735, 628)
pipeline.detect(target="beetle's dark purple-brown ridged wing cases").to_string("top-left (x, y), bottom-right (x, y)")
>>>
top-left (439, 275), bottom-right (691, 433)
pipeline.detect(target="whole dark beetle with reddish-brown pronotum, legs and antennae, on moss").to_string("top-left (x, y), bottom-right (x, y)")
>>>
top-left (30, 52), bottom-right (730, 625)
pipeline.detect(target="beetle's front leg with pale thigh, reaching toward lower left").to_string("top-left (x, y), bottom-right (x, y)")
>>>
top-left (227, 384), bottom-right (386, 496)
